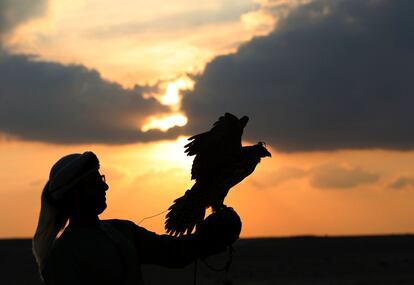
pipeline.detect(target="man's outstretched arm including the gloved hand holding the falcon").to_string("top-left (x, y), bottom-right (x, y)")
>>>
top-left (113, 208), bottom-right (241, 267)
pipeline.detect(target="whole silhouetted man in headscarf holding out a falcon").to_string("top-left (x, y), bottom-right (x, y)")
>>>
top-left (33, 151), bottom-right (241, 285)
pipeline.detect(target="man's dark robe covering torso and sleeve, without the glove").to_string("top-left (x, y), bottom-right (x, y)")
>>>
top-left (42, 220), bottom-right (206, 285)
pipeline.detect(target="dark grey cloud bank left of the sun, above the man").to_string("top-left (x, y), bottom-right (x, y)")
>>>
top-left (0, 53), bottom-right (179, 144)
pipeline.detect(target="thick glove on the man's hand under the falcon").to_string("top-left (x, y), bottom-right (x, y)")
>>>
top-left (195, 208), bottom-right (242, 258)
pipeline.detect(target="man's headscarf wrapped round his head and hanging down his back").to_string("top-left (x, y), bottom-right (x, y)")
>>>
top-left (32, 151), bottom-right (99, 272)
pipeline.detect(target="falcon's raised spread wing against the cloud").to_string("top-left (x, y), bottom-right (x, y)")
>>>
top-left (185, 113), bottom-right (249, 181)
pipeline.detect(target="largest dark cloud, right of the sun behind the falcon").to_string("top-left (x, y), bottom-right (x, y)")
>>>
top-left (183, 0), bottom-right (414, 152)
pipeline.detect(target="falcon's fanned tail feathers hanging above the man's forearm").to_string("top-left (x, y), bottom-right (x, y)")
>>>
top-left (165, 187), bottom-right (206, 236)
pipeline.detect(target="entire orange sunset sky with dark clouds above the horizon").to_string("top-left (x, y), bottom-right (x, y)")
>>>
top-left (0, 0), bottom-right (414, 238)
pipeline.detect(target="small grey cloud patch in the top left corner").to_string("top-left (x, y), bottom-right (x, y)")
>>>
top-left (0, 0), bottom-right (48, 37)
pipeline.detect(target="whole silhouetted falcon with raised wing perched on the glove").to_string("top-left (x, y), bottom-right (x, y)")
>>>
top-left (165, 113), bottom-right (271, 236)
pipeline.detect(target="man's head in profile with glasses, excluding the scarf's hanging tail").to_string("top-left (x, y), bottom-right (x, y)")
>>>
top-left (48, 151), bottom-right (108, 215)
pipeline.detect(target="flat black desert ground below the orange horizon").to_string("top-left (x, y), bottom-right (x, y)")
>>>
top-left (0, 235), bottom-right (414, 285)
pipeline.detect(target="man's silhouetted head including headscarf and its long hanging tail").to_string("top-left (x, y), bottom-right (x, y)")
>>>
top-left (33, 151), bottom-right (108, 270)
